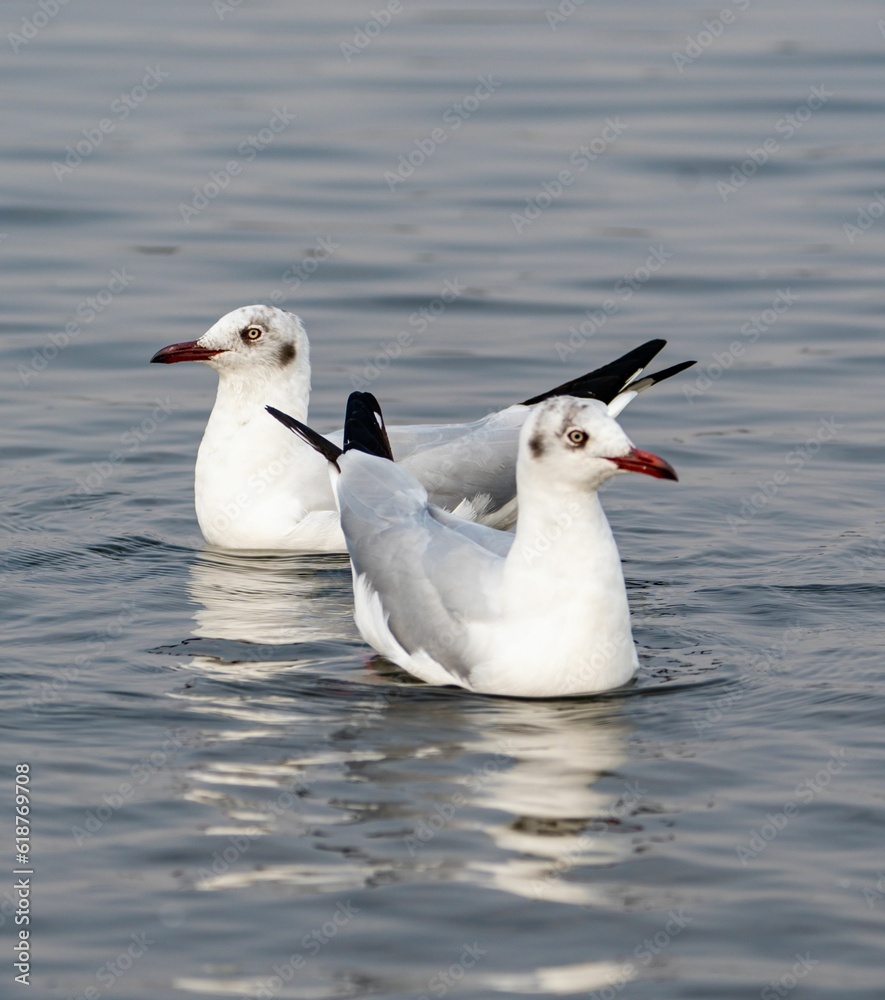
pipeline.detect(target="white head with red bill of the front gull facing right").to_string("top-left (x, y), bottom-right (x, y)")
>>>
top-left (517, 396), bottom-right (676, 491)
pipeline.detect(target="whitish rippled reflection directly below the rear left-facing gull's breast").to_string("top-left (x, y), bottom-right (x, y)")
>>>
top-left (164, 550), bottom-right (365, 744)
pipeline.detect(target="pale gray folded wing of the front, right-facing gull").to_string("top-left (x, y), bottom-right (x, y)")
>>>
top-left (336, 452), bottom-right (513, 678)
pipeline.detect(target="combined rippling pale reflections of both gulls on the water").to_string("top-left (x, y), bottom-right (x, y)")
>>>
top-left (175, 552), bottom-right (639, 997)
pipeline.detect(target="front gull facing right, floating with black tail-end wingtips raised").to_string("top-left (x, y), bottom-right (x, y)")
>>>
top-left (267, 392), bottom-right (676, 698)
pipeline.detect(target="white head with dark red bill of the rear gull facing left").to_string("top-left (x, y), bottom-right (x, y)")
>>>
top-left (151, 305), bottom-right (310, 382)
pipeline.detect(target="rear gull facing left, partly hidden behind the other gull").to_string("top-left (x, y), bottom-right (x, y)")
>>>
top-left (151, 305), bottom-right (694, 552)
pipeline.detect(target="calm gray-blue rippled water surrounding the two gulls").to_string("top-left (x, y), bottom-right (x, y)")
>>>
top-left (0, 0), bottom-right (885, 1000)
